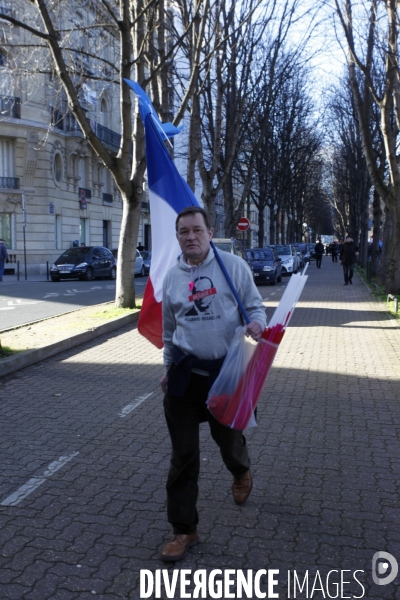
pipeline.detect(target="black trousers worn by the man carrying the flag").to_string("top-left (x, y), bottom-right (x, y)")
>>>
top-left (164, 373), bottom-right (250, 534)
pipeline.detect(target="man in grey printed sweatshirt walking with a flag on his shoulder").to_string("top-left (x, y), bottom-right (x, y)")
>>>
top-left (160, 206), bottom-right (266, 561)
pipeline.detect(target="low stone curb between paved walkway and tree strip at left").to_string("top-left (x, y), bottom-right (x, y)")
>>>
top-left (0, 311), bottom-right (140, 377)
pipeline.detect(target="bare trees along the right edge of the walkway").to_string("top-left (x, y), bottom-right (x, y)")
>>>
top-left (331, 0), bottom-right (400, 294)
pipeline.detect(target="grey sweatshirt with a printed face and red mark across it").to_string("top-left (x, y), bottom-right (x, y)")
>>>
top-left (162, 248), bottom-right (267, 370)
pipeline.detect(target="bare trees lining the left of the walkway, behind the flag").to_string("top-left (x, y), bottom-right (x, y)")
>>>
top-left (0, 0), bottom-right (321, 306)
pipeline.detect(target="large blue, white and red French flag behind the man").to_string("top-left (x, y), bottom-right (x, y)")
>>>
top-left (125, 79), bottom-right (199, 348)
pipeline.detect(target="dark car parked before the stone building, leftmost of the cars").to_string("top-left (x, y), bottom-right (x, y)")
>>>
top-left (50, 246), bottom-right (117, 281)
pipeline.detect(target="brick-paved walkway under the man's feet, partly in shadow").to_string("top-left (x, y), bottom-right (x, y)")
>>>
top-left (0, 257), bottom-right (400, 600)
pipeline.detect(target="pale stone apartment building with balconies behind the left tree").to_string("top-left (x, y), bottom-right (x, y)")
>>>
top-left (0, 0), bottom-right (150, 273)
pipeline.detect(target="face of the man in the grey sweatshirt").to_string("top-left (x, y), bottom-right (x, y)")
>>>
top-left (176, 213), bottom-right (213, 264)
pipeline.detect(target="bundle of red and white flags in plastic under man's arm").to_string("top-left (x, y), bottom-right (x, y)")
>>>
top-left (207, 266), bottom-right (307, 431)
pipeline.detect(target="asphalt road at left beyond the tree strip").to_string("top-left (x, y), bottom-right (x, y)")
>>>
top-left (0, 277), bottom-right (147, 331)
